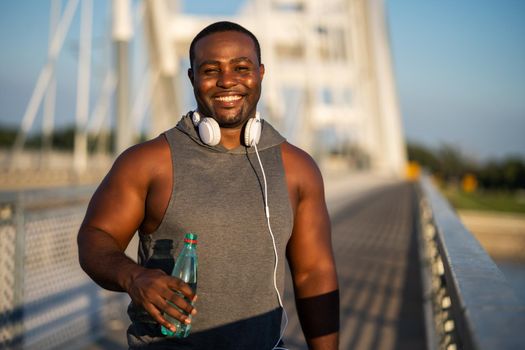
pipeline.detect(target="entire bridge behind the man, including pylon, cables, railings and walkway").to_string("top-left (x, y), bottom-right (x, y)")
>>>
top-left (0, 0), bottom-right (525, 350)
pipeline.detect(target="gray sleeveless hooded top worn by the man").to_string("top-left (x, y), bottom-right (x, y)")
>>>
top-left (128, 115), bottom-right (293, 349)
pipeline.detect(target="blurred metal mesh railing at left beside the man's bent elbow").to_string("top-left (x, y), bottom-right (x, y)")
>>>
top-left (0, 187), bottom-right (127, 350)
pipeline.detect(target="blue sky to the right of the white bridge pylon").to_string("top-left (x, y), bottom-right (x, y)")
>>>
top-left (388, 0), bottom-right (525, 158)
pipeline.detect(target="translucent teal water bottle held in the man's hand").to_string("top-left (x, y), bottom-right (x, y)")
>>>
top-left (161, 233), bottom-right (198, 338)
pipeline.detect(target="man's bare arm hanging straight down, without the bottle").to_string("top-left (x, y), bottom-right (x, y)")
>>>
top-left (282, 144), bottom-right (339, 349)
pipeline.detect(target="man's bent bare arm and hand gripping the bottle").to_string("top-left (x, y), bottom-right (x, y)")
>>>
top-left (77, 138), bottom-right (198, 329)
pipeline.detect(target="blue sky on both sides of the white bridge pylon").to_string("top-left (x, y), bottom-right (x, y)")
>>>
top-left (0, 0), bottom-right (525, 160)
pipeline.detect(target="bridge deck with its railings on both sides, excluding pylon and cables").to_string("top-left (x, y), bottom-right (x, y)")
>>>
top-left (0, 173), bottom-right (525, 350)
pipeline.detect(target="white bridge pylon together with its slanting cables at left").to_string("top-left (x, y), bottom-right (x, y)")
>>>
top-left (11, 0), bottom-right (406, 175)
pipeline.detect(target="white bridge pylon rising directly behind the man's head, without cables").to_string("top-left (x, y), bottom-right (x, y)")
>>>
top-left (135, 0), bottom-right (406, 175)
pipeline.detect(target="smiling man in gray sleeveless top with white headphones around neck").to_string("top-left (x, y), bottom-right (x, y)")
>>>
top-left (78, 22), bottom-right (339, 349)
